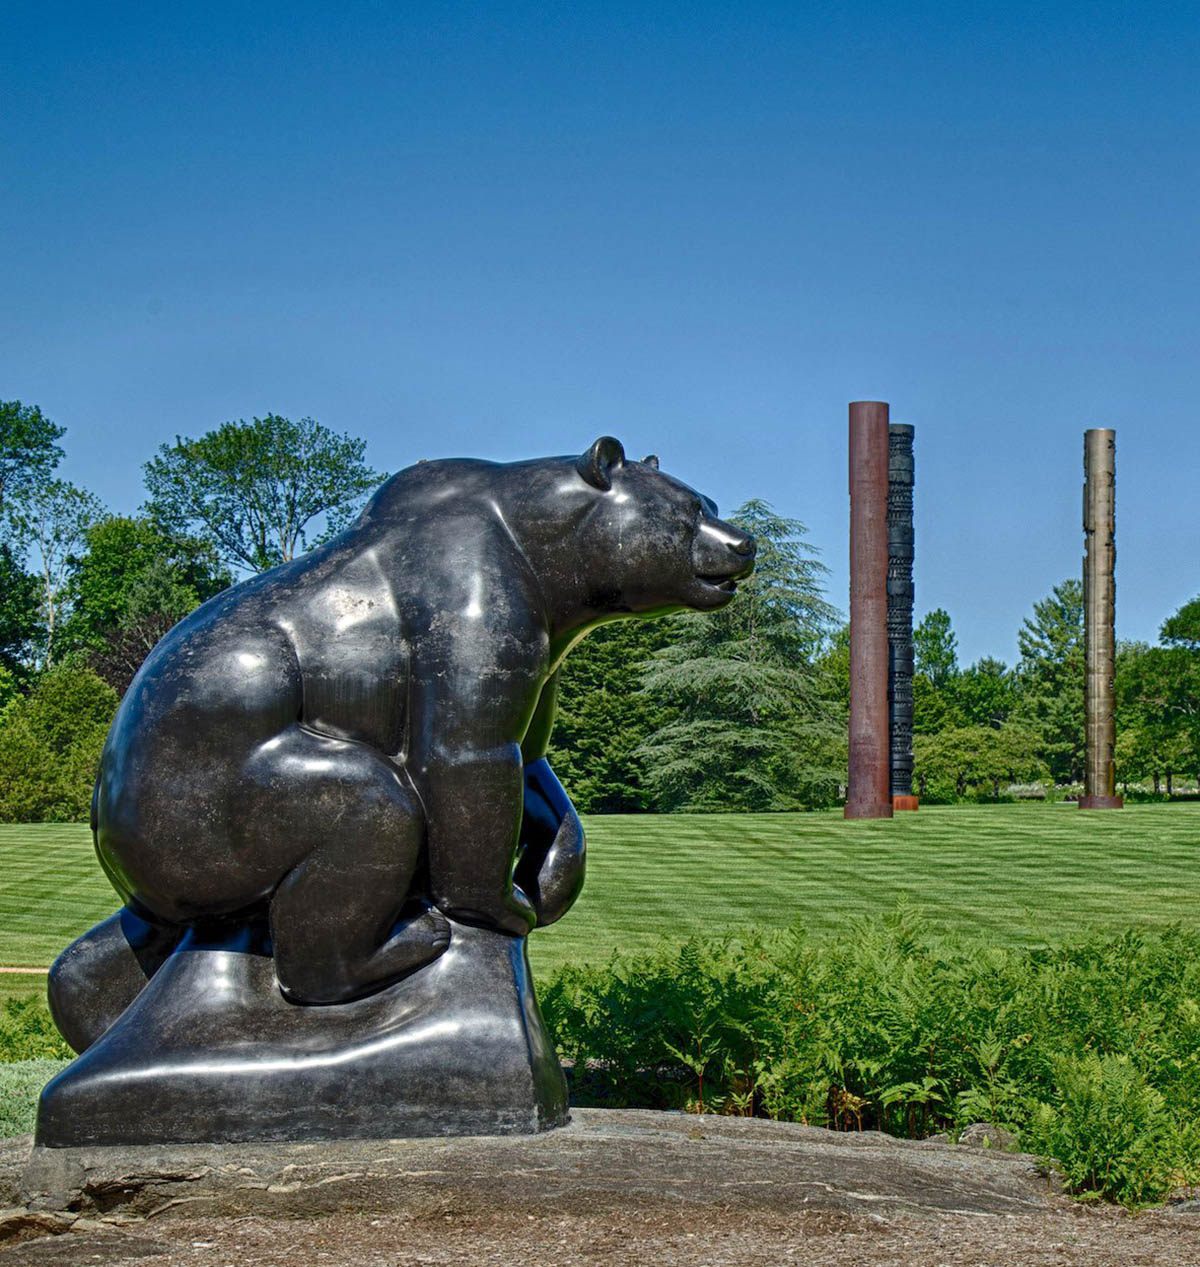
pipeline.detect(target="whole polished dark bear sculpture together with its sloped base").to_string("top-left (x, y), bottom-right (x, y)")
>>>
top-left (37, 437), bottom-right (754, 1147)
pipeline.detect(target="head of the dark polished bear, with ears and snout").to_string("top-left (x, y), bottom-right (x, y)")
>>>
top-left (575, 436), bottom-right (755, 614)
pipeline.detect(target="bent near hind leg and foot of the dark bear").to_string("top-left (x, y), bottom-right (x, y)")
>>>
top-left (253, 730), bottom-right (450, 1003)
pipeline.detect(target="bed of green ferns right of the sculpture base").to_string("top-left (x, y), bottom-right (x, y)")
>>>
top-left (542, 907), bottom-right (1200, 1204)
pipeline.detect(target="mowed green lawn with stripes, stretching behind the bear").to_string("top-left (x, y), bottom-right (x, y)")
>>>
top-left (0, 803), bottom-right (1200, 997)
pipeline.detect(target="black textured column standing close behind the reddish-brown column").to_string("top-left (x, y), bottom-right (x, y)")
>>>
top-left (887, 422), bottom-right (917, 810)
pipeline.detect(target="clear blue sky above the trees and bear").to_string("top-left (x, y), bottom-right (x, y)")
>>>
top-left (0, 0), bottom-right (1200, 661)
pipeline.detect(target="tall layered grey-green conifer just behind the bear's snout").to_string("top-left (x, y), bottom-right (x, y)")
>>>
top-left (639, 500), bottom-right (843, 811)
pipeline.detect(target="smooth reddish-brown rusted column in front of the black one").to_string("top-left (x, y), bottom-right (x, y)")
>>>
top-left (845, 400), bottom-right (892, 818)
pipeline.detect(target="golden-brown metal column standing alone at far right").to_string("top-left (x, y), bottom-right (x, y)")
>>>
top-left (1080, 427), bottom-right (1125, 810)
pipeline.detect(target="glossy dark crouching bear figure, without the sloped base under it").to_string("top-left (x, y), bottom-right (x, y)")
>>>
top-left (39, 437), bottom-right (754, 1144)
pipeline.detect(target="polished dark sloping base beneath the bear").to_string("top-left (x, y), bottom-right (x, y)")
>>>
top-left (35, 924), bottom-right (568, 1148)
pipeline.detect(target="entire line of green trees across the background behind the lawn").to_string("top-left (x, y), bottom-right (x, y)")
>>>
top-left (0, 402), bottom-right (1200, 821)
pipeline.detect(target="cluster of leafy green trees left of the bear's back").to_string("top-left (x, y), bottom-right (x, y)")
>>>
top-left (0, 400), bottom-right (384, 822)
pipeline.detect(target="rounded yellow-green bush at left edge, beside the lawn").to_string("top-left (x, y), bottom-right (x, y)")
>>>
top-left (0, 664), bottom-right (117, 822)
